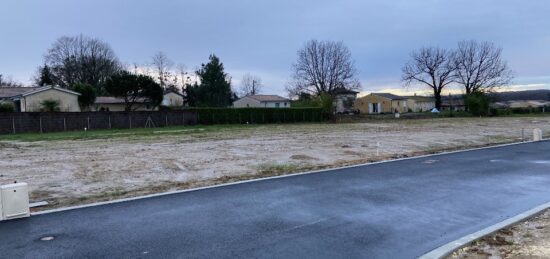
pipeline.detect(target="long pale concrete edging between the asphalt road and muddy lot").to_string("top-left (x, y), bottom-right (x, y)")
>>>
top-left (31, 139), bottom-right (550, 216)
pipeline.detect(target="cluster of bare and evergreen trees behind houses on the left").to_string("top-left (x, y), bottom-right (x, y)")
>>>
top-left (26, 35), bottom-right (262, 111)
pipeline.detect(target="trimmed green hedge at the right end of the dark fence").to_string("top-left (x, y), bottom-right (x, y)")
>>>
top-left (185, 108), bottom-right (328, 124)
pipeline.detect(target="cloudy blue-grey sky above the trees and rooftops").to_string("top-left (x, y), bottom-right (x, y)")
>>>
top-left (0, 0), bottom-right (550, 94)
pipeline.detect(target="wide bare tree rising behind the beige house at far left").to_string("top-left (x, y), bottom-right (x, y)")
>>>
top-left (45, 35), bottom-right (121, 93)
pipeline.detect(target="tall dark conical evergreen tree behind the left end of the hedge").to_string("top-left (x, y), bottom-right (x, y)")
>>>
top-left (194, 55), bottom-right (233, 107)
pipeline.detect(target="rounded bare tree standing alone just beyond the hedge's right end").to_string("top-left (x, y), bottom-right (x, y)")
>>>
top-left (287, 40), bottom-right (361, 96)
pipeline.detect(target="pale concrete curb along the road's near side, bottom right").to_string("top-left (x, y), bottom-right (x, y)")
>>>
top-left (418, 202), bottom-right (550, 259)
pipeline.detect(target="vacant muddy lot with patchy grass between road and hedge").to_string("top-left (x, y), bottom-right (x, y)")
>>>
top-left (0, 117), bottom-right (550, 210)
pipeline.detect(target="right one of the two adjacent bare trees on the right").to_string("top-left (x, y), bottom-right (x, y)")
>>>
top-left (453, 41), bottom-right (512, 94)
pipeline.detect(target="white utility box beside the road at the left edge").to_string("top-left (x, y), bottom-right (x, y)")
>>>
top-left (0, 183), bottom-right (30, 220)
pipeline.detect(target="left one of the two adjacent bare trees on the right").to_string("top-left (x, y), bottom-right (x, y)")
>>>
top-left (402, 47), bottom-right (454, 109)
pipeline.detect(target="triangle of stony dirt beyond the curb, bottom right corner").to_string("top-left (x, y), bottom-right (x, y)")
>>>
top-left (447, 210), bottom-right (550, 259)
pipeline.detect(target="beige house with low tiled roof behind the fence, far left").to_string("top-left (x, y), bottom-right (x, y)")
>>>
top-left (0, 86), bottom-right (80, 112)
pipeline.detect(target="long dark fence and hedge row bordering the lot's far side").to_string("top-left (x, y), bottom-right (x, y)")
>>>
top-left (0, 108), bottom-right (327, 134)
